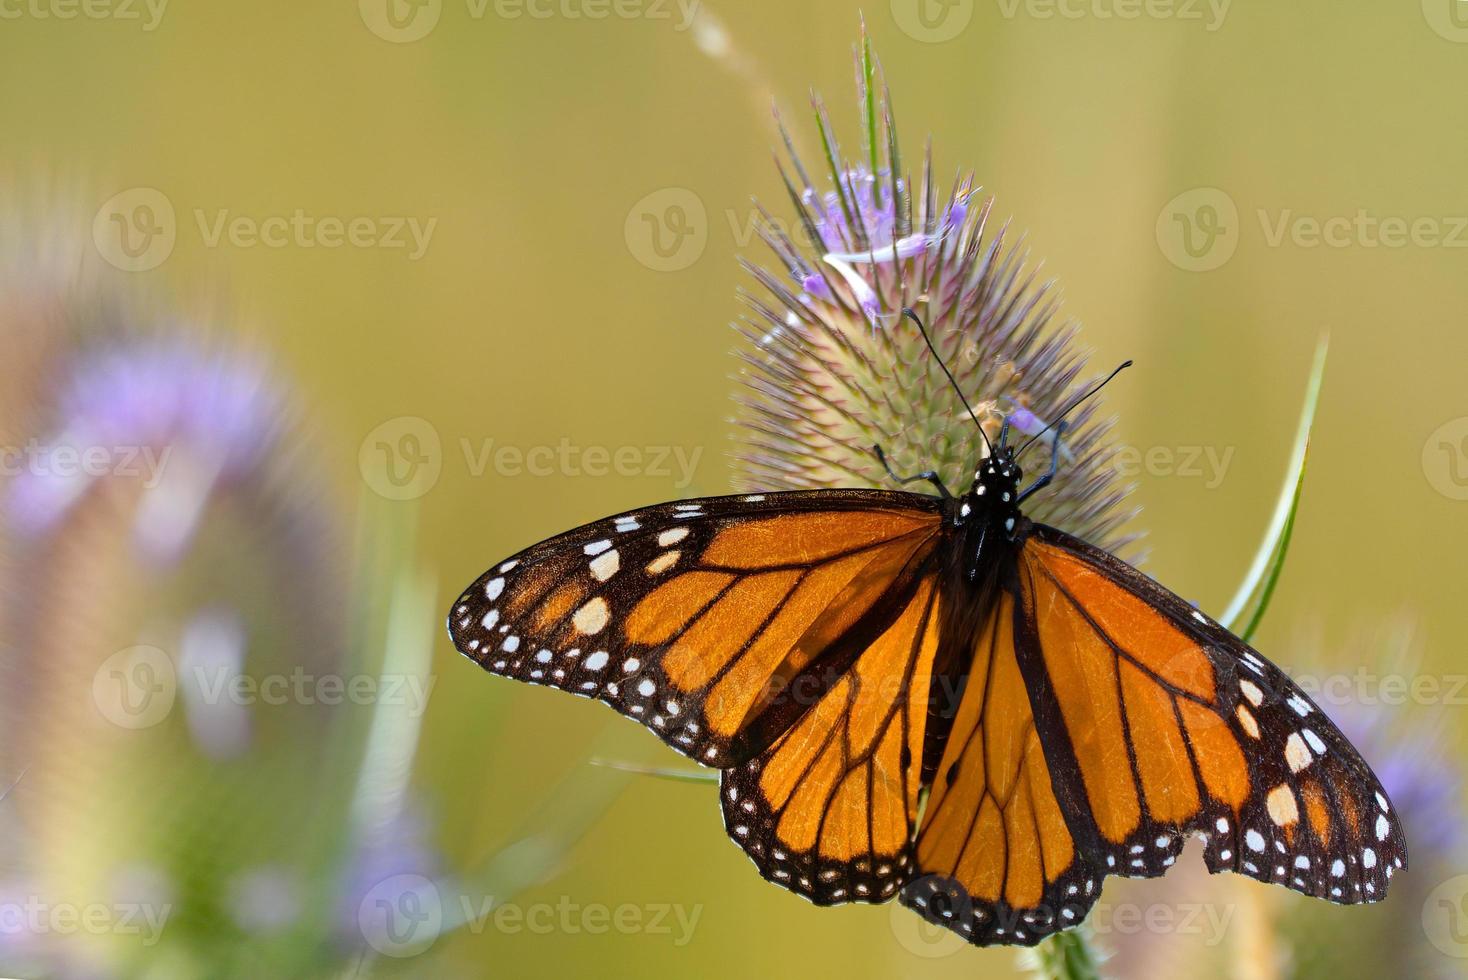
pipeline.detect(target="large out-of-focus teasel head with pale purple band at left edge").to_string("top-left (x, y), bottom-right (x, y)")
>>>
top-left (0, 275), bottom-right (351, 976)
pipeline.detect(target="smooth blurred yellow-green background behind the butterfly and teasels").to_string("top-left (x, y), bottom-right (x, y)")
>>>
top-left (0, 0), bottom-right (1468, 977)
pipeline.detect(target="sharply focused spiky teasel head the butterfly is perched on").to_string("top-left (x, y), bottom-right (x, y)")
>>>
top-left (735, 38), bottom-right (1129, 550)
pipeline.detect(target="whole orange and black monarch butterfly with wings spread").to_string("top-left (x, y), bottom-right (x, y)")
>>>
top-left (449, 311), bottom-right (1406, 946)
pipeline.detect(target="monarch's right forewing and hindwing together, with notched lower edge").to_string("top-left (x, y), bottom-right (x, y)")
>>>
top-left (903, 524), bottom-right (1406, 945)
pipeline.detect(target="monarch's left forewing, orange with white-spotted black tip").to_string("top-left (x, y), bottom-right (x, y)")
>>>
top-left (449, 490), bottom-right (940, 767)
